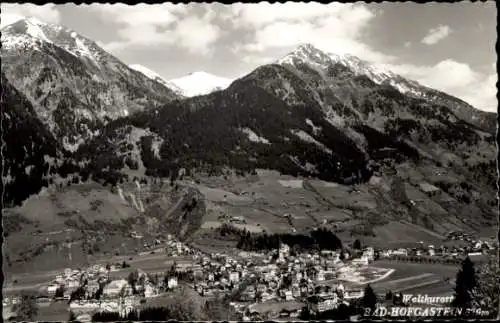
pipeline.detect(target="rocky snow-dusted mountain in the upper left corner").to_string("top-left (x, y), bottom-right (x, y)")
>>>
top-left (1, 18), bottom-right (179, 151)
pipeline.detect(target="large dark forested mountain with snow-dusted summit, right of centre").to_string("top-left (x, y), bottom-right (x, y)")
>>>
top-left (73, 43), bottom-right (496, 240)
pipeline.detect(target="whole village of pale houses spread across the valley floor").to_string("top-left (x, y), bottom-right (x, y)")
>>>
top-left (3, 229), bottom-right (494, 321)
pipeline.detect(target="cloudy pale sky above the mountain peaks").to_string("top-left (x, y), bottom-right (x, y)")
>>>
top-left (0, 1), bottom-right (498, 112)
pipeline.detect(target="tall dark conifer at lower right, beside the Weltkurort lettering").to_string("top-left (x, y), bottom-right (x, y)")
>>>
top-left (452, 257), bottom-right (477, 308)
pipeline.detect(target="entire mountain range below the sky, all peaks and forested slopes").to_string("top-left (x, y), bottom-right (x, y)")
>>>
top-left (1, 18), bottom-right (496, 219)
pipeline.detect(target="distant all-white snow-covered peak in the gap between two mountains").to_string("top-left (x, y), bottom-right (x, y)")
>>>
top-left (169, 72), bottom-right (231, 97)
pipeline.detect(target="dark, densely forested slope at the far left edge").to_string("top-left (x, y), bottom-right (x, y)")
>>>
top-left (0, 71), bottom-right (62, 205)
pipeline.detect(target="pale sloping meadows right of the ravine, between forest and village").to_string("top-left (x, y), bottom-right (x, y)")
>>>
top-left (191, 168), bottom-right (488, 256)
